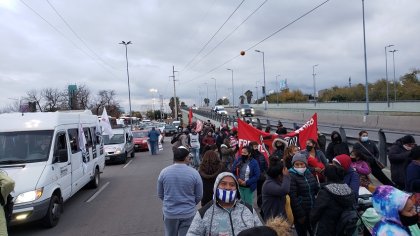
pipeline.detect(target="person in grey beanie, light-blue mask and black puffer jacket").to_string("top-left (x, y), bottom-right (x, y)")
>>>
top-left (289, 153), bottom-right (319, 236)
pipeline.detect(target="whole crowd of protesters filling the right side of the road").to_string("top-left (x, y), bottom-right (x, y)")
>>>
top-left (158, 120), bottom-right (420, 236)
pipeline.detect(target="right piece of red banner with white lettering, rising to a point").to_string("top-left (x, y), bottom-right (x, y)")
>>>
top-left (283, 113), bottom-right (318, 149)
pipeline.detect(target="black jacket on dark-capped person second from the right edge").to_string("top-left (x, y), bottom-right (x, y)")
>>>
top-left (388, 140), bottom-right (410, 188)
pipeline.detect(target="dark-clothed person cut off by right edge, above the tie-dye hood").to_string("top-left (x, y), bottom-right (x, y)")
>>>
top-left (405, 146), bottom-right (420, 193)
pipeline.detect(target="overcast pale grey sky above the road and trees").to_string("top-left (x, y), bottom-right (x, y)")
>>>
top-left (0, 0), bottom-right (420, 110)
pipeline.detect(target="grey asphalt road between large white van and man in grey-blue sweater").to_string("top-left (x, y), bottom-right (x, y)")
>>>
top-left (9, 138), bottom-right (172, 236)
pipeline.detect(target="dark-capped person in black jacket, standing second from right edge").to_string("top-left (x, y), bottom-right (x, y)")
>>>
top-left (388, 135), bottom-right (416, 189)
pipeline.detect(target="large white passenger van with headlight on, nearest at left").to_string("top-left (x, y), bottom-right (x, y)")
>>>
top-left (0, 111), bottom-right (105, 227)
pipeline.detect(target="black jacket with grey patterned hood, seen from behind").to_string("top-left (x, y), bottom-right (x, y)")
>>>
top-left (311, 183), bottom-right (355, 236)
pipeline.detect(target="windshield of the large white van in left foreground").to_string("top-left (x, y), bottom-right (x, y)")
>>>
top-left (0, 130), bottom-right (54, 164)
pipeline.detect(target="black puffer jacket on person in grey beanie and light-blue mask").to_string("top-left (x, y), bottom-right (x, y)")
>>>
top-left (289, 168), bottom-right (319, 220)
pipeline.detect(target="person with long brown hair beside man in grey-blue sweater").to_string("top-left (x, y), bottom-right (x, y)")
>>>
top-left (198, 150), bottom-right (227, 206)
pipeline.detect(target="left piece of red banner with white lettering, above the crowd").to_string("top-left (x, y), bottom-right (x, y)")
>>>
top-left (238, 119), bottom-right (278, 163)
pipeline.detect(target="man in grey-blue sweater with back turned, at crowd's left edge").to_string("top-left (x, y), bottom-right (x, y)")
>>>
top-left (157, 146), bottom-right (203, 236)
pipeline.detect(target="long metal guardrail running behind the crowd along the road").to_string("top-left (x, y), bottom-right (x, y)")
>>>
top-left (183, 110), bottom-right (420, 166)
